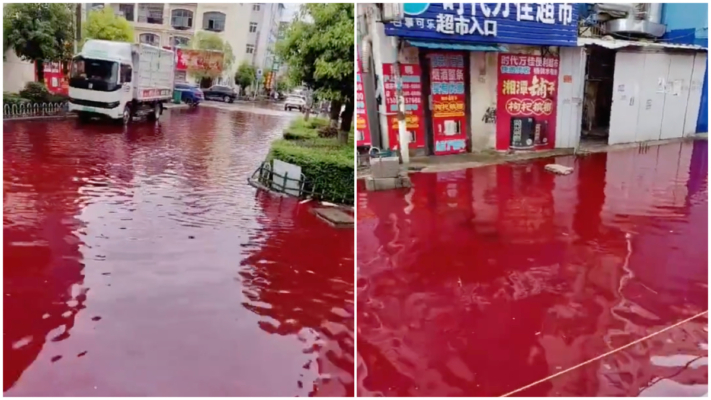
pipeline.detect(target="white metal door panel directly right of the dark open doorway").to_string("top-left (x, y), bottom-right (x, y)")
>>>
top-left (607, 51), bottom-right (644, 144)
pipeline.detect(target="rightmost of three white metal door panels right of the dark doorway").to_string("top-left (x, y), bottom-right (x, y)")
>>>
top-left (659, 54), bottom-right (694, 139)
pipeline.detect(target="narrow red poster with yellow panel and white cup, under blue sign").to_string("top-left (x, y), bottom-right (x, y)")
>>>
top-left (428, 53), bottom-right (467, 155)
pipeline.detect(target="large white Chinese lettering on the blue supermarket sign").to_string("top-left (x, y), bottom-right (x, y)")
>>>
top-left (392, 3), bottom-right (573, 36)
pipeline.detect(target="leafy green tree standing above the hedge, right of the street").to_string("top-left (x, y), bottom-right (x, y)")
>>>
top-left (277, 3), bottom-right (355, 143)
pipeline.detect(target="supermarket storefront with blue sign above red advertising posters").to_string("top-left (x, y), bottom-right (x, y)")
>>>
top-left (382, 3), bottom-right (579, 155)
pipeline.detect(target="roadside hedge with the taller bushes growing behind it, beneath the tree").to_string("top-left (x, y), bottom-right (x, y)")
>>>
top-left (267, 118), bottom-right (355, 204)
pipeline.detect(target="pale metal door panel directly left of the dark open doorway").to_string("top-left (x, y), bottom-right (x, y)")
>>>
top-left (555, 47), bottom-right (587, 148)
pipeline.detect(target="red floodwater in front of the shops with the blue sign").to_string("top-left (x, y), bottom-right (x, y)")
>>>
top-left (357, 141), bottom-right (708, 396)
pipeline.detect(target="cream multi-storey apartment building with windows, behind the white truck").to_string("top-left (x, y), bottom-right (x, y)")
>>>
top-left (85, 3), bottom-right (284, 84)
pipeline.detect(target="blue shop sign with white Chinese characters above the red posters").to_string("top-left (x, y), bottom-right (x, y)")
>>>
top-left (385, 3), bottom-right (578, 46)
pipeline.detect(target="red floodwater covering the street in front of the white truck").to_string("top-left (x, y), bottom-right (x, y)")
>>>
top-left (3, 108), bottom-right (354, 396)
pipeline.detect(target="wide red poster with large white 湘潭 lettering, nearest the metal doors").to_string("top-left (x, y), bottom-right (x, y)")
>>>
top-left (496, 54), bottom-right (558, 150)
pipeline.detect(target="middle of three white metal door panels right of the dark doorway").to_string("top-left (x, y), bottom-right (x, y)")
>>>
top-left (635, 53), bottom-right (671, 142)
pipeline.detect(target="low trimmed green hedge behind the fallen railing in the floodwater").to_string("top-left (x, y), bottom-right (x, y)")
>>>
top-left (268, 139), bottom-right (354, 204)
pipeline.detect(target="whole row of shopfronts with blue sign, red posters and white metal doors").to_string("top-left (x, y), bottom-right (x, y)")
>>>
top-left (358, 3), bottom-right (707, 155)
